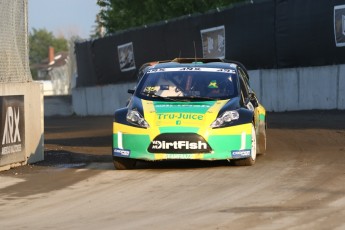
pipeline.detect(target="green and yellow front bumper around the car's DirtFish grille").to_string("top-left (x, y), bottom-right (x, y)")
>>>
top-left (112, 122), bottom-right (252, 161)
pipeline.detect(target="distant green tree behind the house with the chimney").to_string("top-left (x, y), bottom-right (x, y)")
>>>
top-left (29, 28), bottom-right (68, 79)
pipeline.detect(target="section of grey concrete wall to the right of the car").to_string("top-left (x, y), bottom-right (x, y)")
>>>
top-left (249, 65), bottom-right (345, 112)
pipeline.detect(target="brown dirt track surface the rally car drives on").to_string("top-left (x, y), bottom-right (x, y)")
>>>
top-left (0, 111), bottom-right (345, 230)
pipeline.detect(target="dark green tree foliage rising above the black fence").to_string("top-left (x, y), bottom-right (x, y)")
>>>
top-left (97, 0), bottom-right (245, 33)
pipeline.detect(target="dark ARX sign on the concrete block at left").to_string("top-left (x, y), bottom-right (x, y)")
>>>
top-left (0, 96), bottom-right (25, 160)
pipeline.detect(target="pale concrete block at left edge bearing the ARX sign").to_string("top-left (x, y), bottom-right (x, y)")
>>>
top-left (0, 82), bottom-right (44, 171)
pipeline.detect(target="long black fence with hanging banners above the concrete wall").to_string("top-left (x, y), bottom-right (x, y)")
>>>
top-left (75, 0), bottom-right (345, 87)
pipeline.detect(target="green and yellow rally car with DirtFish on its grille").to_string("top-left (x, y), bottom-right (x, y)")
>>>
top-left (112, 58), bottom-right (266, 169)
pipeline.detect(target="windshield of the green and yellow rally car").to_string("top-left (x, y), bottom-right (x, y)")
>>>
top-left (136, 68), bottom-right (238, 100)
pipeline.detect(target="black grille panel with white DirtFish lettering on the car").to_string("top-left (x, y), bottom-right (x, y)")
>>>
top-left (148, 133), bottom-right (211, 153)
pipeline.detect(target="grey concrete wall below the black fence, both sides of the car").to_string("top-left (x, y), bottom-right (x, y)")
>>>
top-left (72, 65), bottom-right (345, 116)
